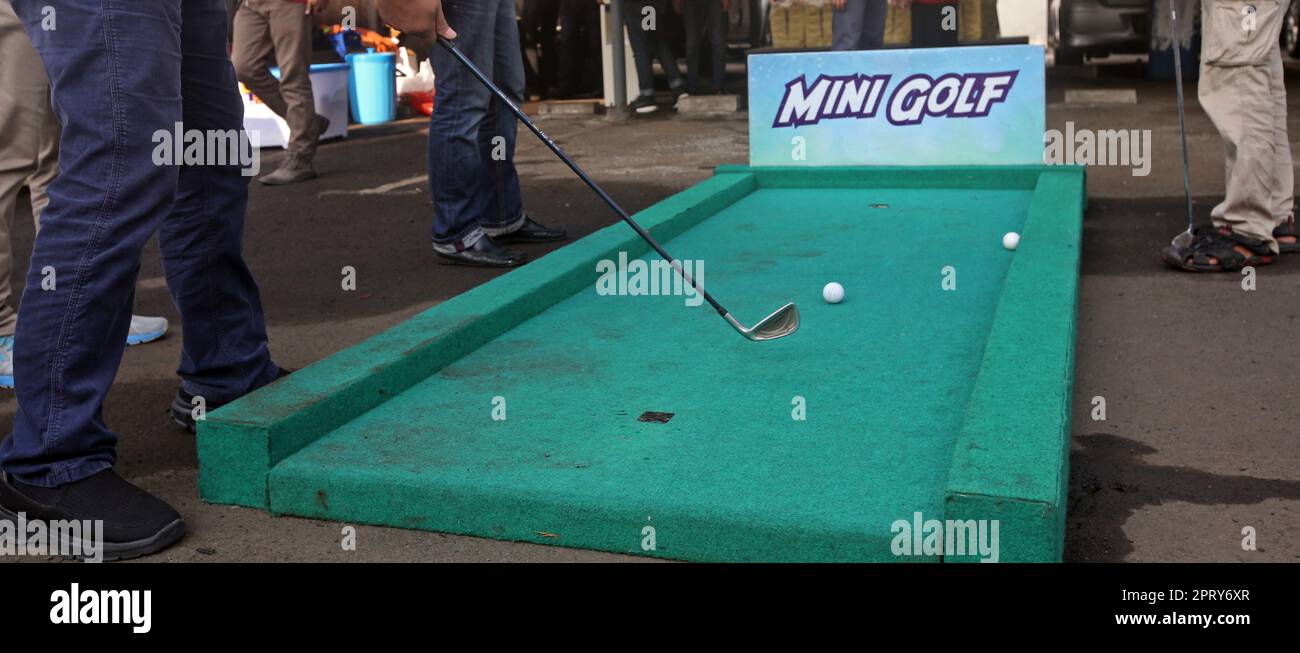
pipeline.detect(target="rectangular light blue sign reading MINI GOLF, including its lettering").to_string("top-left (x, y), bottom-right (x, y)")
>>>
top-left (749, 46), bottom-right (1047, 165)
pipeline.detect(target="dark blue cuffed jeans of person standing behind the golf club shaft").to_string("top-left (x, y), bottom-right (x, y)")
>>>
top-left (429, 0), bottom-right (524, 250)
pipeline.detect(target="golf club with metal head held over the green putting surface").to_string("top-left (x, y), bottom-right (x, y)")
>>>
top-left (438, 35), bottom-right (800, 341)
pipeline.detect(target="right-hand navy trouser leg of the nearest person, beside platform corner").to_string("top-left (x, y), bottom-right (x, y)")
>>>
top-left (166, 0), bottom-right (280, 406)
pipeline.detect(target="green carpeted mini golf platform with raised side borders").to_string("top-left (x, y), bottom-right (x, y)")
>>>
top-left (200, 169), bottom-right (1082, 562)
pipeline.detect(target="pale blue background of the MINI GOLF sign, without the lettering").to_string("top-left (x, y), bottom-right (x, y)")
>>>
top-left (749, 46), bottom-right (1047, 165)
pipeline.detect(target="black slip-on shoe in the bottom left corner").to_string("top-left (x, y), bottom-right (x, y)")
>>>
top-left (0, 470), bottom-right (185, 561)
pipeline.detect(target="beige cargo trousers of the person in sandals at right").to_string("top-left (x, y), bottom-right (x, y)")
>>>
top-left (1200, 0), bottom-right (1291, 252)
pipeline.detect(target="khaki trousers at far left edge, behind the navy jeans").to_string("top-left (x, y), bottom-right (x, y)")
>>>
top-left (0, 1), bottom-right (60, 336)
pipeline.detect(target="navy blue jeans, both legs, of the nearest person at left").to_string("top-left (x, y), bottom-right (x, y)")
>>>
top-left (0, 0), bottom-right (278, 486)
